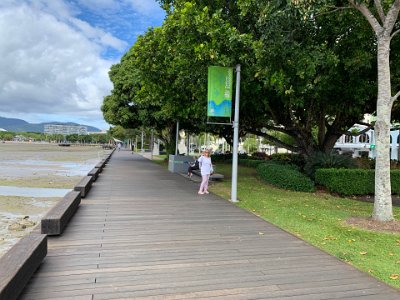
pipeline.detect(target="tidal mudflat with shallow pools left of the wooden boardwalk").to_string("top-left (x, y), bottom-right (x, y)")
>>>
top-left (0, 142), bottom-right (108, 256)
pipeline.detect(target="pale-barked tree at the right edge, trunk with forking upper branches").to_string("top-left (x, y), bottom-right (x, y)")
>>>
top-left (349, 0), bottom-right (400, 221)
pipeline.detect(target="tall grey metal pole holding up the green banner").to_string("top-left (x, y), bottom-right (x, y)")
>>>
top-left (231, 65), bottom-right (240, 202)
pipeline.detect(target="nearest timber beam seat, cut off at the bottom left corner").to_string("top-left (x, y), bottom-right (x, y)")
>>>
top-left (0, 234), bottom-right (47, 300)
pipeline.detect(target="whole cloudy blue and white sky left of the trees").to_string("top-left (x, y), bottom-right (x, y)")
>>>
top-left (0, 0), bottom-right (165, 130)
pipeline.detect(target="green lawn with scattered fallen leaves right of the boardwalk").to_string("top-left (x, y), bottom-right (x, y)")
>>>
top-left (210, 163), bottom-right (400, 288)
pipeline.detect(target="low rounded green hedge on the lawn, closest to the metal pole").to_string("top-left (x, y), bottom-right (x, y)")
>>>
top-left (257, 163), bottom-right (315, 192)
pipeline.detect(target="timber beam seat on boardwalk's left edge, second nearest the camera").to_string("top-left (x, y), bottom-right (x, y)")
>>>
top-left (41, 191), bottom-right (81, 235)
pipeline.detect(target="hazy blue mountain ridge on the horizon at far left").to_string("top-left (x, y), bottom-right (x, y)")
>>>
top-left (0, 117), bottom-right (101, 133)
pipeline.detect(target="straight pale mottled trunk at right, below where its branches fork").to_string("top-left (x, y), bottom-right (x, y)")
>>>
top-left (372, 37), bottom-right (393, 221)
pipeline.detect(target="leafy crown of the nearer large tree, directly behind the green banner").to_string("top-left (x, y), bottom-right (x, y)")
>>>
top-left (155, 0), bottom-right (376, 155)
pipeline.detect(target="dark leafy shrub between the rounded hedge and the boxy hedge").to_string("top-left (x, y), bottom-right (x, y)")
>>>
top-left (304, 152), bottom-right (356, 178)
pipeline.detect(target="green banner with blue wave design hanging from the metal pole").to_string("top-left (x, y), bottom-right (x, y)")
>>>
top-left (207, 66), bottom-right (233, 118)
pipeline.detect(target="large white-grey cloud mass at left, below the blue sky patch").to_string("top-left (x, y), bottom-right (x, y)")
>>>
top-left (0, 0), bottom-right (126, 127)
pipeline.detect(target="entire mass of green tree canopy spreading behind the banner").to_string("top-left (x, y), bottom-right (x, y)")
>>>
top-left (102, 0), bottom-right (398, 155)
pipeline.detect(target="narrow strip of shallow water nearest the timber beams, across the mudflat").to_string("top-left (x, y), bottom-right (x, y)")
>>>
top-left (0, 186), bottom-right (70, 198)
